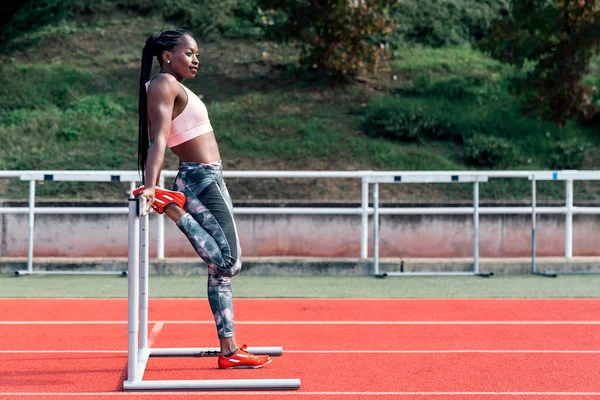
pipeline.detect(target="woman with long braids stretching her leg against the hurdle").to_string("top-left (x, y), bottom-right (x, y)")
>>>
top-left (133, 30), bottom-right (271, 369)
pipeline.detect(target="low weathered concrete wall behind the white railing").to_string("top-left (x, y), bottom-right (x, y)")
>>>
top-left (0, 204), bottom-right (600, 258)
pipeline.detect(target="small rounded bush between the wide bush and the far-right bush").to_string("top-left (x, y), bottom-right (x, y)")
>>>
top-left (464, 134), bottom-right (516, 168)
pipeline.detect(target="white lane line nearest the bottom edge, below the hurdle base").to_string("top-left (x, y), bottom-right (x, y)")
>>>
top-left (0, 391), bottom-right (600, 397)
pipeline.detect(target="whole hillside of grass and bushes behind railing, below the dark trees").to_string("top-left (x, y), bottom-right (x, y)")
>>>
top-left (0, 0), bottom-right (600, 202)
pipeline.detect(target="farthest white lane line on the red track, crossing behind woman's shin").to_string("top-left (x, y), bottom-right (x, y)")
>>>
top-left (0, 320), bottom-right (600, 325)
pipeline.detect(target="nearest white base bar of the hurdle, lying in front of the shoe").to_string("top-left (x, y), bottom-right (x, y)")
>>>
top-left (123, 379), bottom-right (300, 390)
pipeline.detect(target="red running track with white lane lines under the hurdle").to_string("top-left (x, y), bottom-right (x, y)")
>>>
top-left (0, 299), bottom-right (600, 400)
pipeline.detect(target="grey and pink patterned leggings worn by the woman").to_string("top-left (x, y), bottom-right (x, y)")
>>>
top-left (173, 161), bottom-right (242, 338)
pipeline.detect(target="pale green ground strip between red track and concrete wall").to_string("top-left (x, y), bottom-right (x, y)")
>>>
top-left (0, 275), bottom-right (600, 298)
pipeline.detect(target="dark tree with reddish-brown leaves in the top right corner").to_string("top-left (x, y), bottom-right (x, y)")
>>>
top-left (480, 0), bottom-right (600, 125)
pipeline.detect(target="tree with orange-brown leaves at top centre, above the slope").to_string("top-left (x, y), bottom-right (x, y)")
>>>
top-left (258, 0), bottom-right (397, 77)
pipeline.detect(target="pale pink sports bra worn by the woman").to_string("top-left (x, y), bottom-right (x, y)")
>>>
top-left (146, 82), bottom-right (213, 147)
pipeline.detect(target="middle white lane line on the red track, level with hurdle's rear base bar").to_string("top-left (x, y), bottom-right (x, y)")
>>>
top-left (0, 349), bottom-right (600, 354)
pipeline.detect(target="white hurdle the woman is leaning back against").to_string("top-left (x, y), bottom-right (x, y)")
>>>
top-left (123, 199), bottom-right (300, 390)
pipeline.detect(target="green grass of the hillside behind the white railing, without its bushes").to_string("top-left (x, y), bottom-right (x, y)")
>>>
top-left (0, 15), bottom-right (600, 201)
